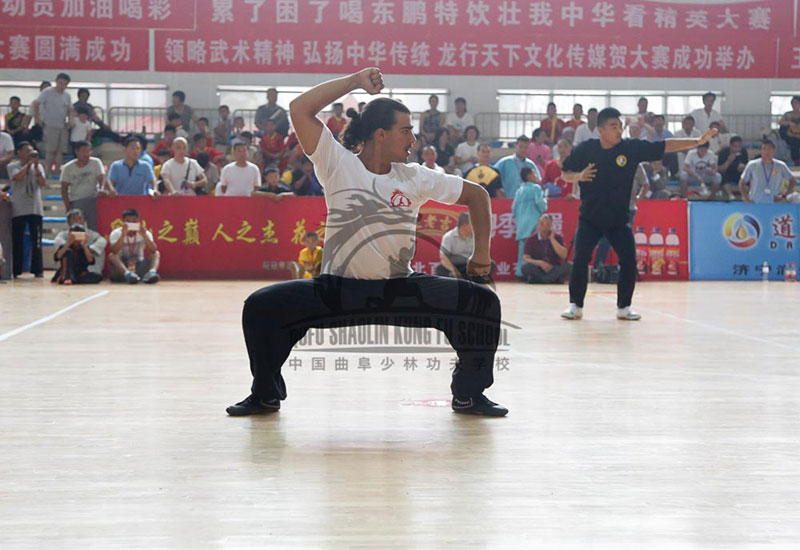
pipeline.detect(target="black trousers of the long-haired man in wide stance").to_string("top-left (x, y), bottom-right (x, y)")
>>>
top-left (242, 273), bottom-right (500, 400)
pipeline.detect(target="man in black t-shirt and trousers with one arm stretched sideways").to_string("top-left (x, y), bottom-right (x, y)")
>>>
top-left (561, 108), bottom-right (717, 321)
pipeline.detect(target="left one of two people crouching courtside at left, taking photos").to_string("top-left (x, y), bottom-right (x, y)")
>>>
top-left (52, 208), bottom-right (106, 285)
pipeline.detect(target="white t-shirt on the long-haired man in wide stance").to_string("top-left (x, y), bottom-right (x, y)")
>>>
top-left (309, 125), bottom-right (463, 279)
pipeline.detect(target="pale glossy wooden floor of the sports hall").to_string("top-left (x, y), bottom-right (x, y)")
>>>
top-left (0, 279), bottom-right (800, 550)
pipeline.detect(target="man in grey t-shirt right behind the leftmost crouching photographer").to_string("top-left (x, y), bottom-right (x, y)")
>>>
top-left (61, 141), bottom-right (106, 230)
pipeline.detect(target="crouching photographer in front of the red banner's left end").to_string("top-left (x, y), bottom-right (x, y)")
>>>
top-left (108, 208), bottom-right (161, 285)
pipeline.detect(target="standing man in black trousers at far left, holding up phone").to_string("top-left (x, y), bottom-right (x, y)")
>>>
top-left (8, 141), bottom-right (47, 277)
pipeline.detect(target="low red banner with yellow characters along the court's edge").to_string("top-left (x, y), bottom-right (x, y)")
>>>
top-left (98, 196), bottom-right (688, 281)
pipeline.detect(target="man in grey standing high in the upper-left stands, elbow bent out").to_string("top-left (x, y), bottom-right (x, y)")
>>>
top-left (33, 73), bottom-right (72, 174)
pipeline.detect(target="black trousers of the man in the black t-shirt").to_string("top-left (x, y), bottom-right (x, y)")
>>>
top-left (569, 219), bottom-right (636, 308)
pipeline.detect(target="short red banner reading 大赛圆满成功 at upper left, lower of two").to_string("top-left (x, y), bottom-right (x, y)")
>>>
top-left (0, 26), bottom-right (149, 71)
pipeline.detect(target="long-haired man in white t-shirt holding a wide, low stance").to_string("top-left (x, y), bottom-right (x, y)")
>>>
top-left (227, 68), bottom-right (508, 416)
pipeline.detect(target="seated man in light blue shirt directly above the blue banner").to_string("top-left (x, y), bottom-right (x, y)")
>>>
top-left (740, 140), bottom-right (797, 203)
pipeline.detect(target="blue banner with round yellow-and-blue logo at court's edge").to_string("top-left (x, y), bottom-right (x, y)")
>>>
top-left (689, 202), bottom-right (800, 280)
